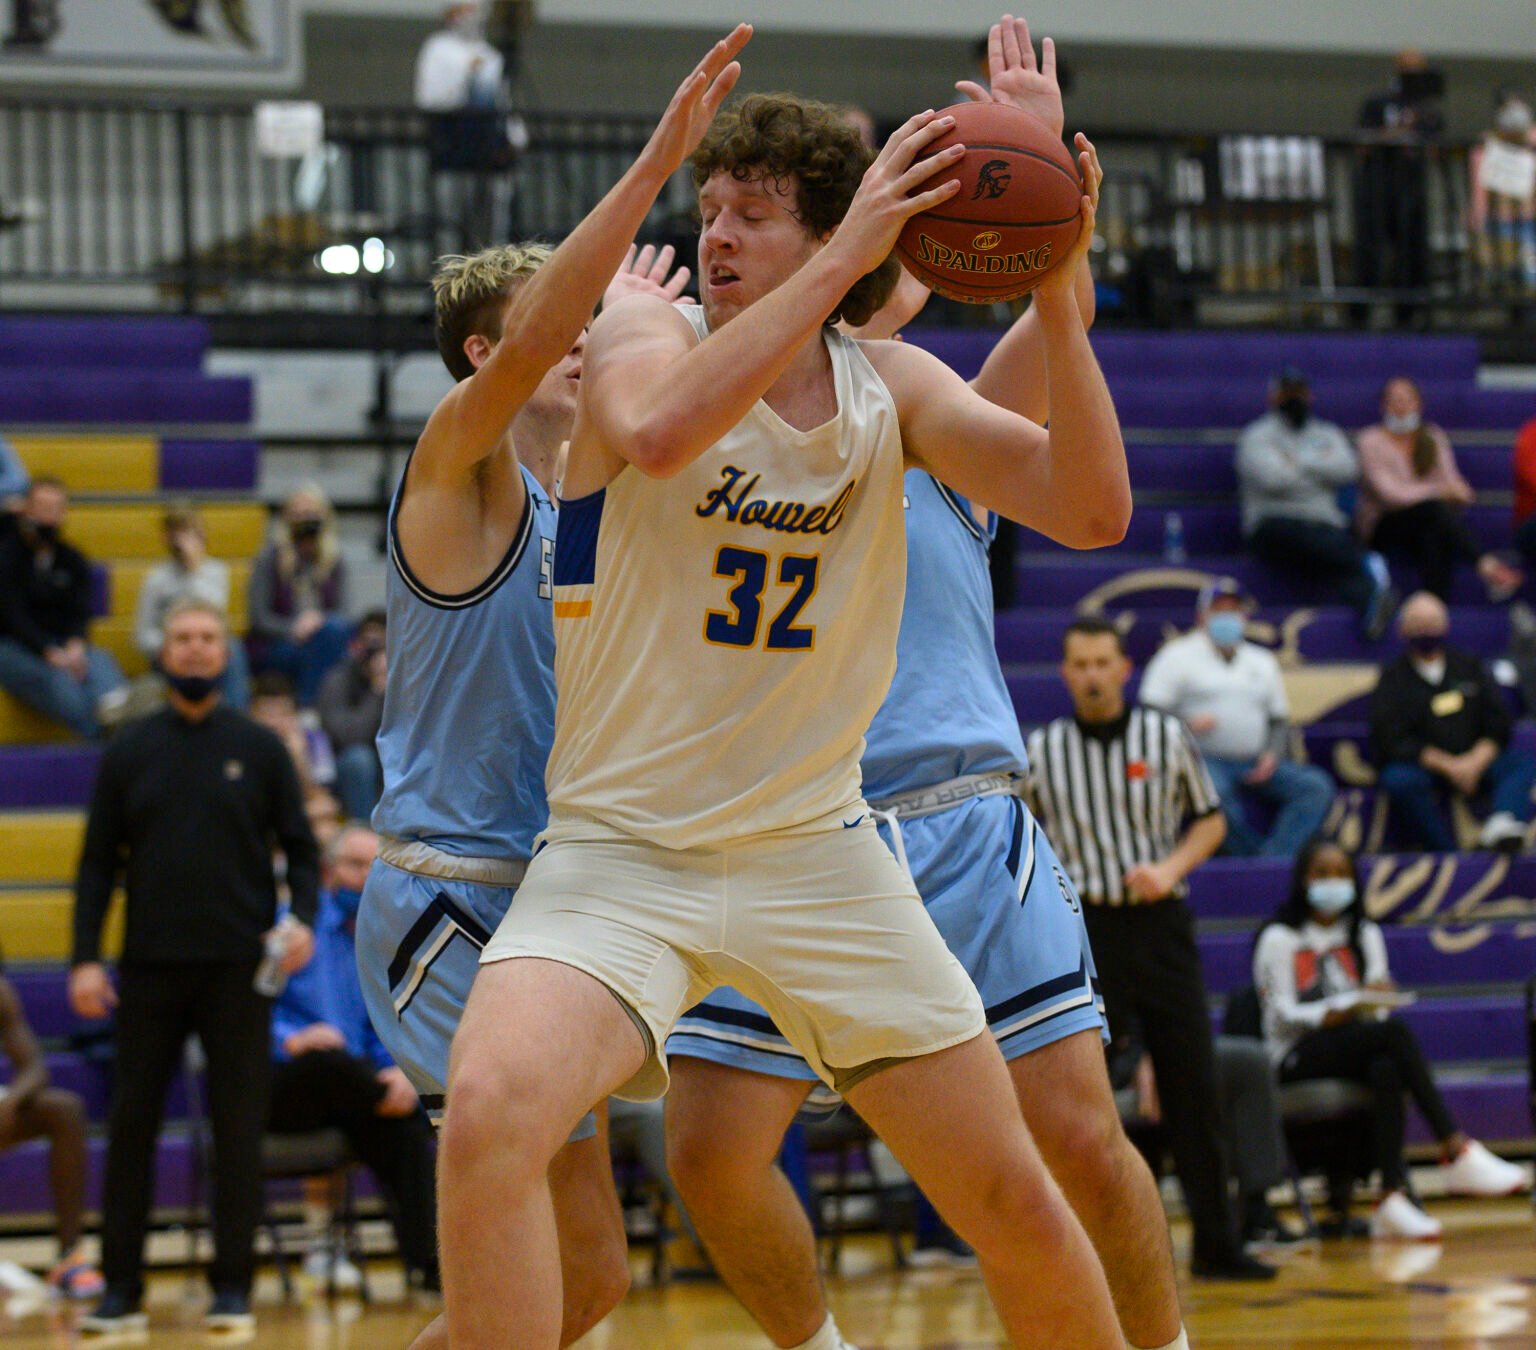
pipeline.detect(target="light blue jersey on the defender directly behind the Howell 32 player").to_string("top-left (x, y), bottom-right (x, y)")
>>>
top-left (862, 468), bottom-right (1028, 802)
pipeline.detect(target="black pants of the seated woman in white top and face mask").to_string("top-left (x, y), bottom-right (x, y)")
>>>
top-left (1279, 1017), bottom-right (1456, 1190)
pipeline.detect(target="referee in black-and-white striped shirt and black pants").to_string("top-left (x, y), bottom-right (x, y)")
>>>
top-left (1029, 619), bottom-right (1275, 1279)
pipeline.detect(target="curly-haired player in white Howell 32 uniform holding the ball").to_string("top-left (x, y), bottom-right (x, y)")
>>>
top-left (439, 60), bottom-right (1130, 1350)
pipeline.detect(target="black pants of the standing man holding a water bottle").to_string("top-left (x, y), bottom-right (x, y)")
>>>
top-left (101, 961), bottom-right (272, 1301)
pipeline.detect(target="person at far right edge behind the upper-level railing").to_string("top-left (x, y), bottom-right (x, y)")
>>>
top-left (1467, 89), bottom-right (1536, 290)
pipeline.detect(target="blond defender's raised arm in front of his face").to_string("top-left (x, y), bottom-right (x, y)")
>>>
top-left (413, 23), bottom-right (753, 478)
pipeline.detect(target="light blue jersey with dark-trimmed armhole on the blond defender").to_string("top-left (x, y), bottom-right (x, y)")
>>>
top-left (373, 468), bottom-right (556, 862)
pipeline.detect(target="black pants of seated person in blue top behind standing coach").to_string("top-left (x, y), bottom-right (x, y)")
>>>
top-left (272, 1051), bottom-right (438, 1276)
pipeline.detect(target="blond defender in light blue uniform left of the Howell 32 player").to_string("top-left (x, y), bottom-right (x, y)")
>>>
top-left (358, 26), bottom-right (751, 1350)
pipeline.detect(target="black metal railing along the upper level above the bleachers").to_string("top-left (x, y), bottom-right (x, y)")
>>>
top-left (0, 97), bottom-right (1536, 342)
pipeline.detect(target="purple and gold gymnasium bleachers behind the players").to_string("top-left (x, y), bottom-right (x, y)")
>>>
top-left (0, 318), bottom-right (1536, 1247)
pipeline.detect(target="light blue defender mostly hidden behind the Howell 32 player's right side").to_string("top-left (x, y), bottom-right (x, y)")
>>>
top-left (667, 20), bottom-right (1187, 1350)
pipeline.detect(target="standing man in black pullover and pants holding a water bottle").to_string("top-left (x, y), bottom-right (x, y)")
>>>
top-left (69, 601), bottom-right (318, 1332)
